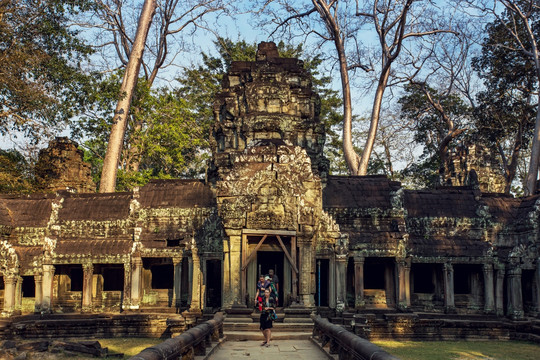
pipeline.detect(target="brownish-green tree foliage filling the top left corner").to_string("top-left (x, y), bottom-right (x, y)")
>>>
top-left (0, 0), bottom-right (96, 141)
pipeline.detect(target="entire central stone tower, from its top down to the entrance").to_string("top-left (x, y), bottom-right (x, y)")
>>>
top-left (208, 43), bottom-right (338, 311)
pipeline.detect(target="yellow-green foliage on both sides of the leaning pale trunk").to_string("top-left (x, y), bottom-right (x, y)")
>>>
top-left (73, 72), bottom-right (208, 190)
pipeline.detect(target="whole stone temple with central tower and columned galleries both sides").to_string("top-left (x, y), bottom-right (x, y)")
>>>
top-left (0, 43), bottom-right (540, 336)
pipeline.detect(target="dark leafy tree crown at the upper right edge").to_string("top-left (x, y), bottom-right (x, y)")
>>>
top-left (473, 5), bottom-right (540, 194)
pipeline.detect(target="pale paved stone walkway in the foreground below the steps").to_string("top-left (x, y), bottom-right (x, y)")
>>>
top-left (208, 340), bottom-right (328, 360)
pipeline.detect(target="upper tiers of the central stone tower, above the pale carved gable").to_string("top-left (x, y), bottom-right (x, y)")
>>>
top-left (210, 42), bottom-right (329, 180)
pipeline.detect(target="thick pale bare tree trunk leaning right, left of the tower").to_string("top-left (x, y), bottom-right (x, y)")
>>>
top-left (99, 0), bottom-right (156, 193)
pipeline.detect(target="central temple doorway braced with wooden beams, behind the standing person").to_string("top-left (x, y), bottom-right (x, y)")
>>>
top-left (241, 230), bottom-right (298, 307)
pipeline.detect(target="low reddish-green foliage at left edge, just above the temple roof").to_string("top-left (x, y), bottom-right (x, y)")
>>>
top-left (0, 150), bottom-right (35, 194)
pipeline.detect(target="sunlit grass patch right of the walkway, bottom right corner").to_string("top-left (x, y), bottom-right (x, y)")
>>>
top-left (373, 340), bottom-right (540, 360)
